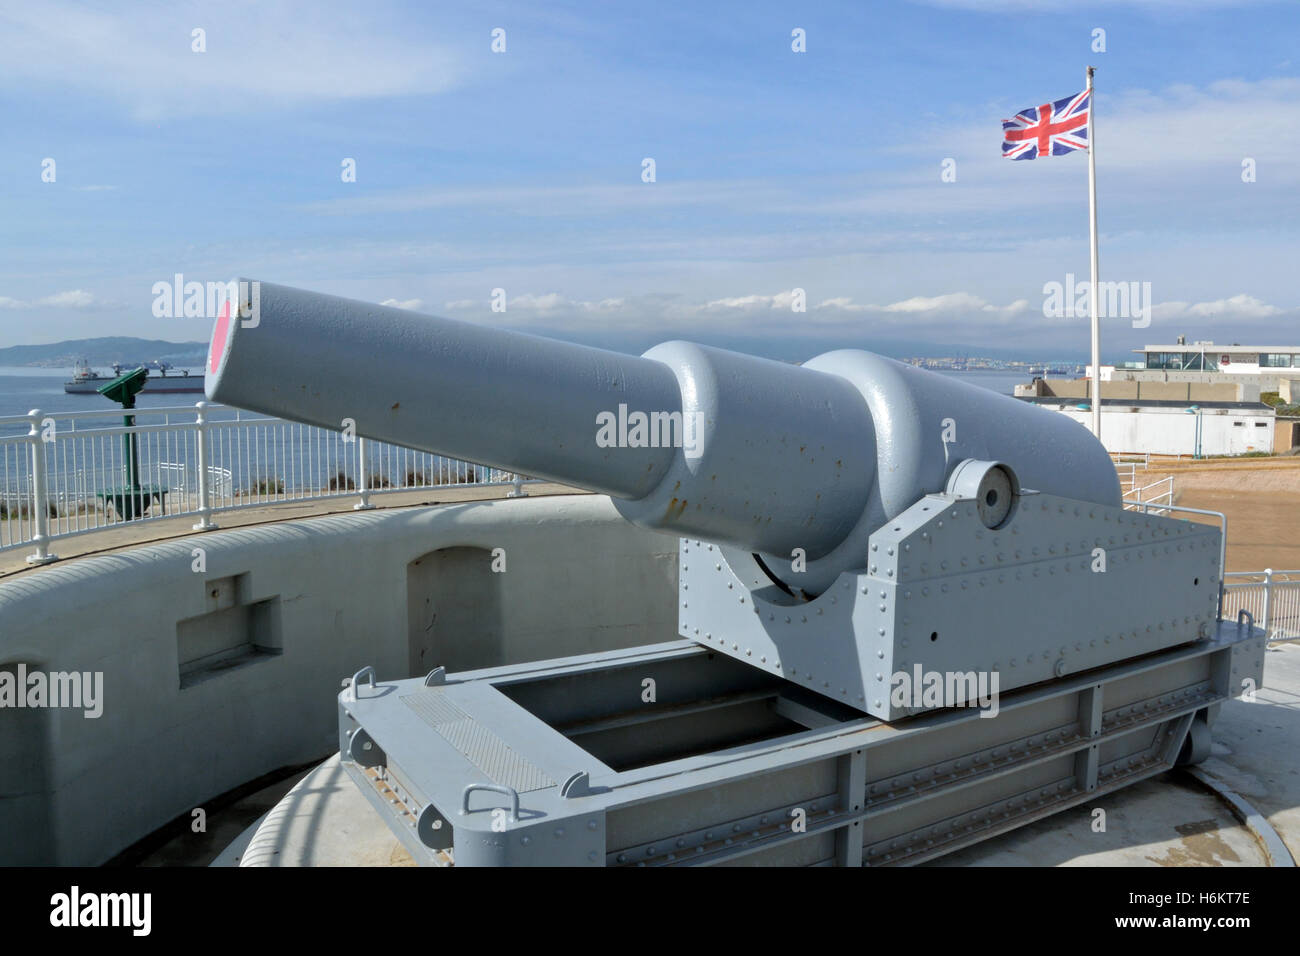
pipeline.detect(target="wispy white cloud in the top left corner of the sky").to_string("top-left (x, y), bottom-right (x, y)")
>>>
top-left (0, 0), bottom-right (463, 119)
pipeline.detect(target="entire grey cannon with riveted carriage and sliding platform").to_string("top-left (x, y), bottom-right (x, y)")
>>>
top-left (207, 282), bottom-right (1264, 865)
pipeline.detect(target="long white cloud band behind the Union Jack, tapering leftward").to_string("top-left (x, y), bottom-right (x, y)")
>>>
top-left (300, 77), bottom-right (1300, 238)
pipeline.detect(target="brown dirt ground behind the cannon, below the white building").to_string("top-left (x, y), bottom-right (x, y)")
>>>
top-left (1138, 459), bottom-right (1300, 571)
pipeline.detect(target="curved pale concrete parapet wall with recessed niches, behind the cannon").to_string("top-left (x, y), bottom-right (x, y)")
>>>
top-left (0, 496), bottom-right (676, 865)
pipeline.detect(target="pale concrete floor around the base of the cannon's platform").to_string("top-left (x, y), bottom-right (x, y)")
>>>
top-left (212, 643), bottom-right (1300, 866)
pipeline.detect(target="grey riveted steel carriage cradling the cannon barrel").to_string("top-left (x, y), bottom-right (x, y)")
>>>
top-left (679, 492), bottom-right (1222, 721)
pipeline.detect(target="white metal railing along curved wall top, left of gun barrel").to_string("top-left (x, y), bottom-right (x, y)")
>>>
top-left (0, 402), bottom-right (532, 564)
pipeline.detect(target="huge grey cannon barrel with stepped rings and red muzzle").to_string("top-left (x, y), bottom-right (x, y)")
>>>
top-left (205, 280), bottom-right (1119, 591)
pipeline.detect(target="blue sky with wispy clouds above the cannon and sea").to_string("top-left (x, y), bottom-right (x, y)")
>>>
top-left (0, 0), bottom-right (1300, 359)
